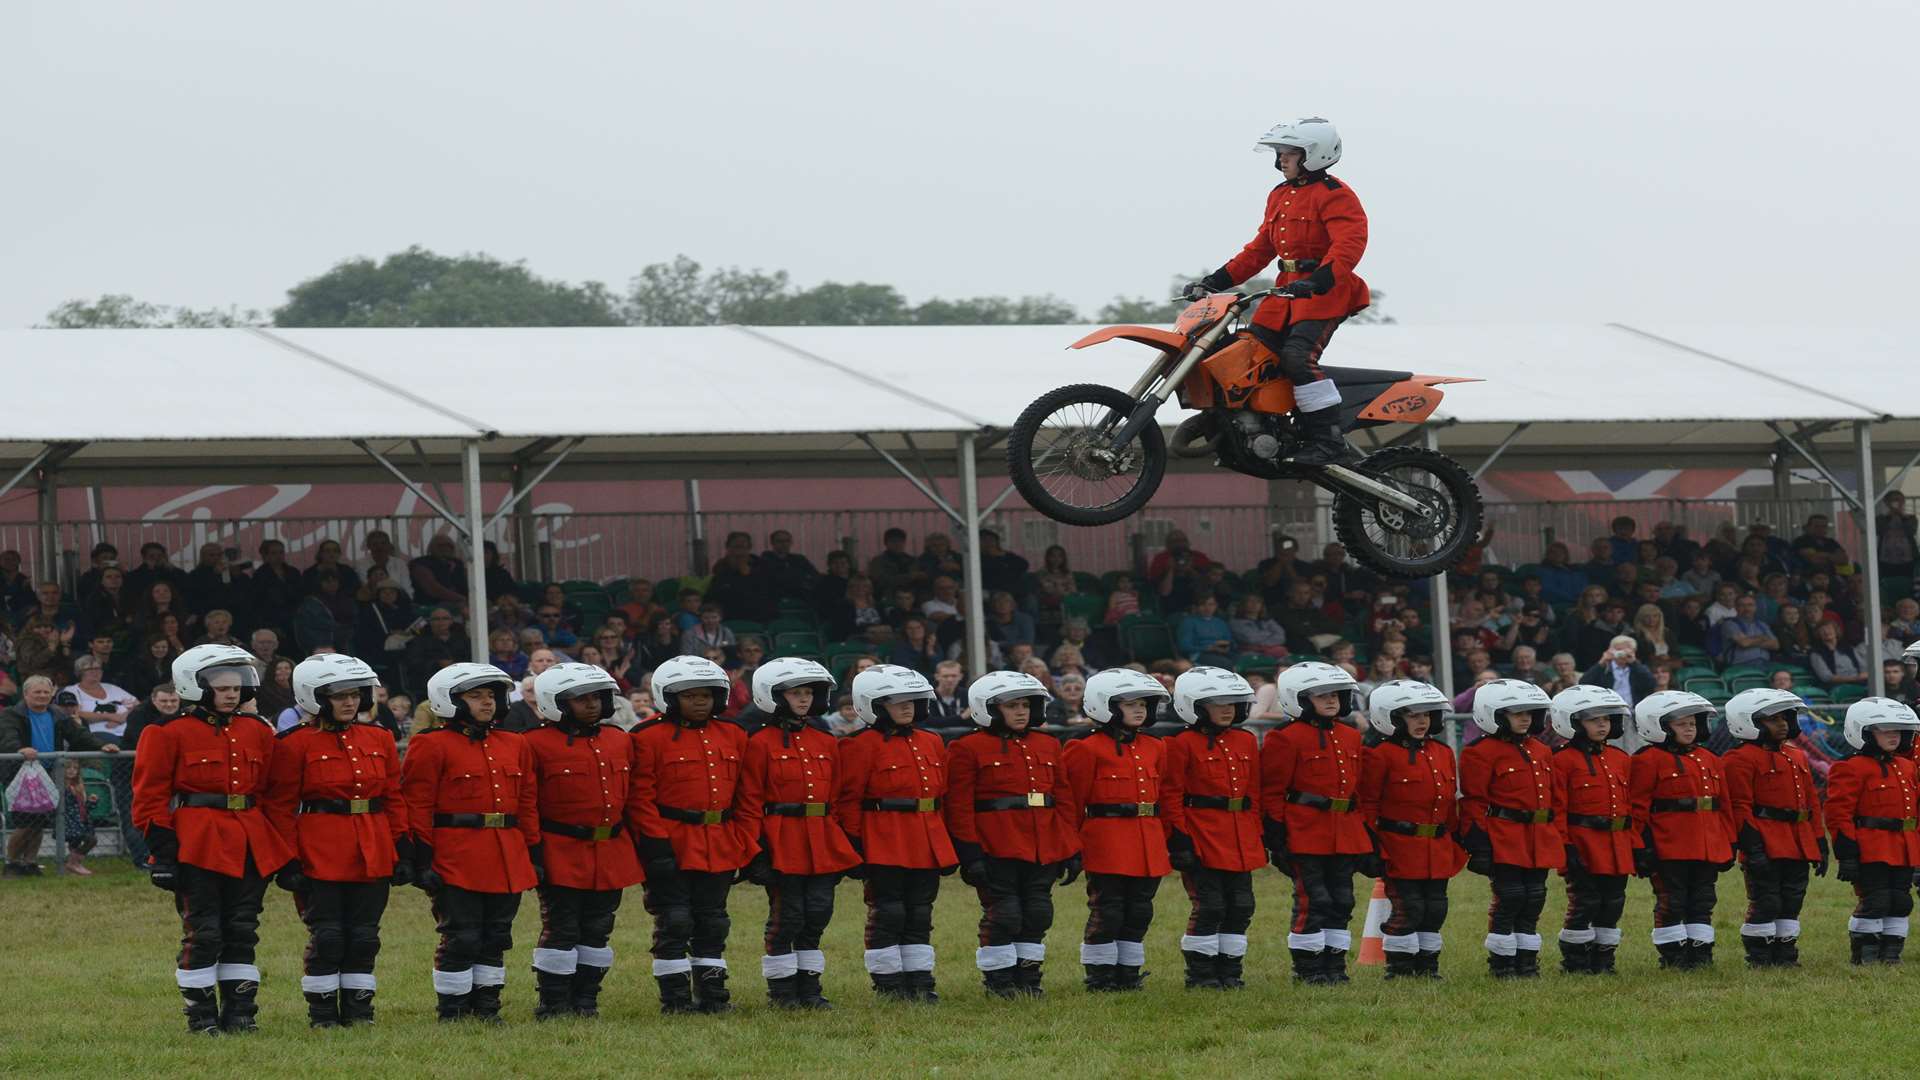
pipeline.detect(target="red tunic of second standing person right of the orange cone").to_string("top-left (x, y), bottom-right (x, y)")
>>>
top-left (1459, 736), bottom-right (1567, 871)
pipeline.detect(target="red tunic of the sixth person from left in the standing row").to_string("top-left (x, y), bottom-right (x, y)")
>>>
top-left (739, 724), bottom-right (860, 874)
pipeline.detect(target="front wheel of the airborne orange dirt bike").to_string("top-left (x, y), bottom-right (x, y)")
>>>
top-left (1006, 382), bottom-right (1167, 525)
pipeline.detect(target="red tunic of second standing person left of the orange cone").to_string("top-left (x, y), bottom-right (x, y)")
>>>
top-left (1160, 728), bottom-right (1267, 871)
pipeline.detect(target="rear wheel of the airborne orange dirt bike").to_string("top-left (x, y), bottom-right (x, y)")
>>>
top-left (1332, 446), bottom-right (1482, 578)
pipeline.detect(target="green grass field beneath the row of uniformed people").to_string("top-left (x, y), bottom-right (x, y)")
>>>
top-left (0, 861), bottom-right (1920, 1080)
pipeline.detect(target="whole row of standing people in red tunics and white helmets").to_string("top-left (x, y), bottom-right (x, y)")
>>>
top-left (134, 646), bottom-right (1920, 1032)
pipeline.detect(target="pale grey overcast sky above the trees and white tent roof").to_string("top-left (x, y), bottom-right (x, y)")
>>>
top-left (0, 0), bottom-right (1920, 328)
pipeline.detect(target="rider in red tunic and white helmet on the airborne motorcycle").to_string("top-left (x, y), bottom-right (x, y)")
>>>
top-left (1187, 117), bottom-right (1371, 465)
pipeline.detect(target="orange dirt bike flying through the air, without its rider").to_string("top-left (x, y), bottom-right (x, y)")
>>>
top-left (1006, 282), bottom-right (1480, 577)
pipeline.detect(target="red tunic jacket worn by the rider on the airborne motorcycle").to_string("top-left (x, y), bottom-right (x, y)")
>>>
top-left (1221, 177), bottom-right (1373, 320)
